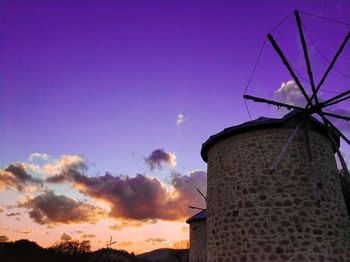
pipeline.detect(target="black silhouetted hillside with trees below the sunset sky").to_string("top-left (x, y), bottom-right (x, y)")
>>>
top-left (0, 239), bottom-right (188, 262)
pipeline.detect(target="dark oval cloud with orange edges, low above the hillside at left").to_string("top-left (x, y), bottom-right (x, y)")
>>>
top-left (18, 191), bottom-right (105, 224)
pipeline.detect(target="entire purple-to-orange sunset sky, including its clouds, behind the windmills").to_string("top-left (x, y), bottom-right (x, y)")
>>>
top-left (0, 0), bottom-right (350, 253)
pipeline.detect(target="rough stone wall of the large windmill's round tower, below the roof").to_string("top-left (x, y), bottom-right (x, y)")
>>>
top-left (206, 123), bottom-right (350, 262)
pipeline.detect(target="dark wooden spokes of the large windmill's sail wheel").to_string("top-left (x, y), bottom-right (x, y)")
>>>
top-left (243, 10), bottom-right (350, 190)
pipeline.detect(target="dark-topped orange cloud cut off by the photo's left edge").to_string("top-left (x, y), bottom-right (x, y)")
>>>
top-left (0, 163), bottom-right (42, 191)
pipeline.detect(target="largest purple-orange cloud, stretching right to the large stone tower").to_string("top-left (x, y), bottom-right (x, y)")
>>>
top-left (45, 167), bottom-right (206, 220)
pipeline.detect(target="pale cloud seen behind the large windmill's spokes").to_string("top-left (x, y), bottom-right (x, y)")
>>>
top-left (274, 80), bottom-right (306, 107)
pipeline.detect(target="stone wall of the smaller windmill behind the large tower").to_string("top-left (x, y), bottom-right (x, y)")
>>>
top-left (190, 220), bottom-right (207, 262)
